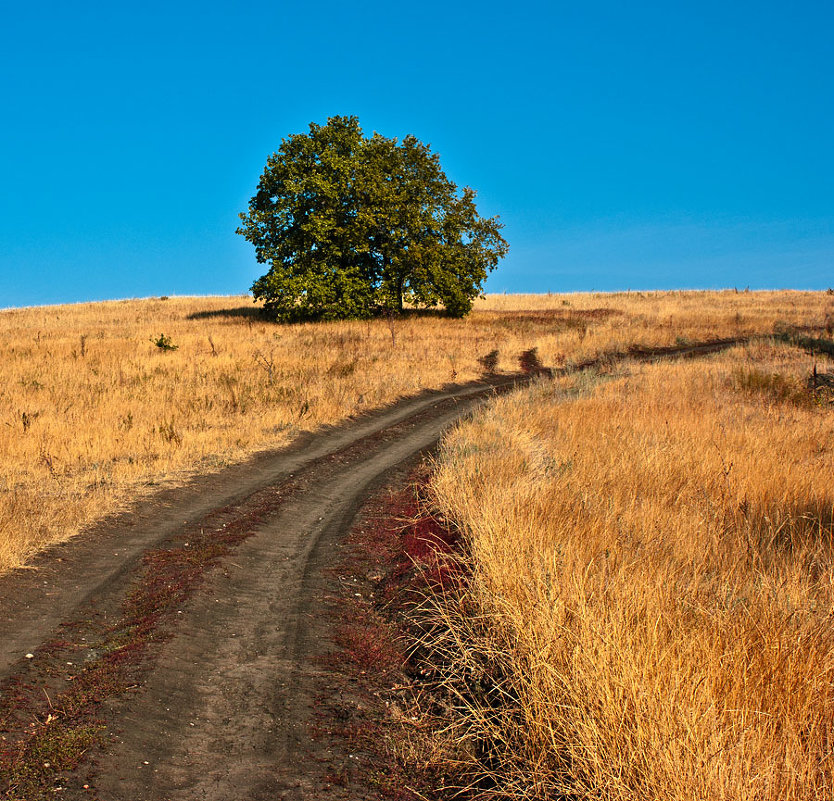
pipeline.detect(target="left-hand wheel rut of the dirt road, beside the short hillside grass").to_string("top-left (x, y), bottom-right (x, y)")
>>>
top-left (0, 376), bottom-right (523, 680)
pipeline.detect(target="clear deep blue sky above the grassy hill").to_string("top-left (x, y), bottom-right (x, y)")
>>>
top-left (0, 0), bottom-right (834, 307)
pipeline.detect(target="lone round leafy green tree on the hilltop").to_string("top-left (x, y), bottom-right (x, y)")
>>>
top-left (237, 117), bottom-right (507, 321)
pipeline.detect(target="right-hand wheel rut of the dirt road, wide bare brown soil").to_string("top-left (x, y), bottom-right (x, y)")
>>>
top-left (86, 400), bottom-right (476, 801)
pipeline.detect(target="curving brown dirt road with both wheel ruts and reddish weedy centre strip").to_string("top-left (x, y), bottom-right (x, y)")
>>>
top-left (0, 376), bottom-right (522, 801)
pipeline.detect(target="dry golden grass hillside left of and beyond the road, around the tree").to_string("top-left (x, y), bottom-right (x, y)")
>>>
top-left (0, 292), bottom-right (834, 571)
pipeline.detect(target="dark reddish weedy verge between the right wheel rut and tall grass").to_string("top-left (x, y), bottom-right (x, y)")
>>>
top-left (306, 465), bottom-right (465, 801)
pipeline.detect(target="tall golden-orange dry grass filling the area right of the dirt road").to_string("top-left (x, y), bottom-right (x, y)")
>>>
top-left (433, 343), bottom-right (834, 801)
